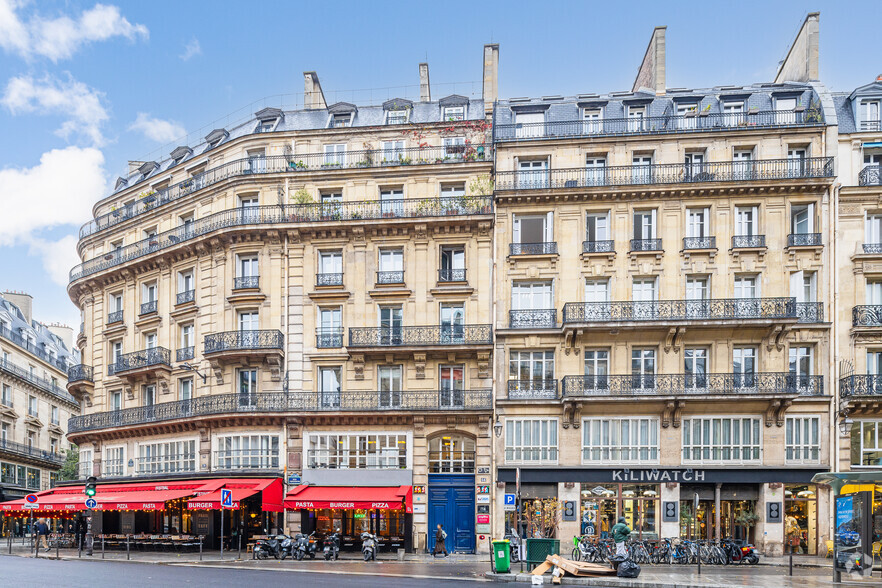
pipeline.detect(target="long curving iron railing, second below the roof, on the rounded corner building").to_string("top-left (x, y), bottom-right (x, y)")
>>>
top-left (70, 196), bottom-right (493, 281)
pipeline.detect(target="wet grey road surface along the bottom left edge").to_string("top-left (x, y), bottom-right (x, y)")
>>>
top-left (0, 556), bottom-right (488, 588)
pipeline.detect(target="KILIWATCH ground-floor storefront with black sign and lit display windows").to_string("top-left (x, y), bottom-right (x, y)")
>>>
top-left (494, 467), bottom-right (830, 555)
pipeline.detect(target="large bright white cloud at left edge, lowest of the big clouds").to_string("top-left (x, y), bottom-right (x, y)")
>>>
top-left (0, 146), bottom-right (106, 249)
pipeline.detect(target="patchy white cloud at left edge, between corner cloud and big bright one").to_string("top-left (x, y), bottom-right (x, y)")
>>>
top-left (0, 73), bottom-right (109, 146)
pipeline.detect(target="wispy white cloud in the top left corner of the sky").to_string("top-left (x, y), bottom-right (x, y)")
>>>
top-left (0, 0), bottom-right (150, 61)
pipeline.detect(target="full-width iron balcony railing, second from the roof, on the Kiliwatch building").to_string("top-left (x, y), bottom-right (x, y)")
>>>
top-left (496, 157), bottom-right (833, 190)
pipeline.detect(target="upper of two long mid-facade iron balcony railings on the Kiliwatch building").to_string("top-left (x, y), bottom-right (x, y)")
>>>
top-left (563, 298), bottom-right (798, 325)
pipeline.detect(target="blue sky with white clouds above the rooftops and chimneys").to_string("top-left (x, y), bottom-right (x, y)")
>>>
top-left (0, 0), bottom-right (882, 326)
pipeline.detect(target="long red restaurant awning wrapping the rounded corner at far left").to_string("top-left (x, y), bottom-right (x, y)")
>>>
top-left (0, 478), bottom-right (282, 514)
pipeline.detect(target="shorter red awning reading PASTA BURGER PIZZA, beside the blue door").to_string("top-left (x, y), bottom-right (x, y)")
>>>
top-left (285, 484), bottom-right (413, 512)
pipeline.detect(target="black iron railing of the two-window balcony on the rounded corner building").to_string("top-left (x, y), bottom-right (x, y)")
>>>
top-left (349, 325), bottom-right (493, 347)
